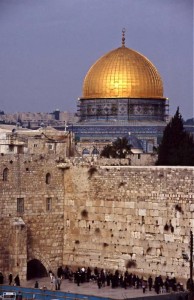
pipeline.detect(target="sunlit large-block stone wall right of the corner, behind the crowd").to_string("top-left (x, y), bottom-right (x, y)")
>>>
top-left (63, 166), bottom-right (194, 278)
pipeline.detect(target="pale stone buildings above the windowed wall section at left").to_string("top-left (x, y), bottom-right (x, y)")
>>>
top-left (0, 125), bottom-right (75, 157)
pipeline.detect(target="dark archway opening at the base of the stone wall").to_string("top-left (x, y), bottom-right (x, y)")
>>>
top-left (27, 259), bottom-right (48, 280)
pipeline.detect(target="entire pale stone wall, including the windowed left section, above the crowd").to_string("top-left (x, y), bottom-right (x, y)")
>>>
top-left (0, 154), bottom-right (194, 279)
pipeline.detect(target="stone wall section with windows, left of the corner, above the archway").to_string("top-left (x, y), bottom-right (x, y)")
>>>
top-left (0, 155), bottom-right (64, 278)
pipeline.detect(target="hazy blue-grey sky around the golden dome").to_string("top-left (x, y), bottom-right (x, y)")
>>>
top-left (0, 0), bottom-right (194, 119)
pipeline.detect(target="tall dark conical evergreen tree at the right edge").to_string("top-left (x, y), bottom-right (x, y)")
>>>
top-left (156, 107), bottom-right (194, 166)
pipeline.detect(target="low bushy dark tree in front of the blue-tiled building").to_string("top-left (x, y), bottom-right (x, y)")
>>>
top-left (101, 137), bottom-right (131, 158)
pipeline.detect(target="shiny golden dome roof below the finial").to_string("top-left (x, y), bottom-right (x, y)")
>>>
top-left (82, 45), bottom-right (163, 99)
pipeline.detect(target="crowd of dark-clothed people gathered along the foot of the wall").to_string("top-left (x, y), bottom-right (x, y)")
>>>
top-left (49, 266), bottom-right (184, 294)
